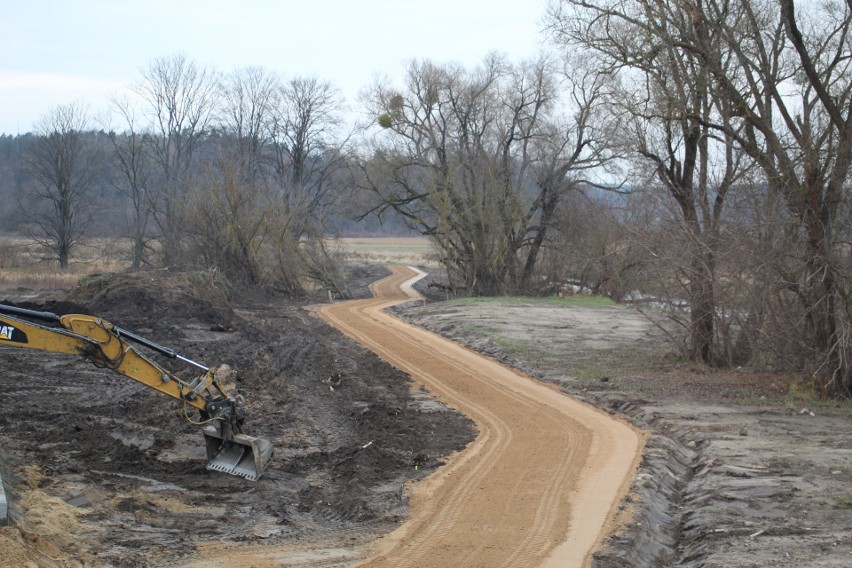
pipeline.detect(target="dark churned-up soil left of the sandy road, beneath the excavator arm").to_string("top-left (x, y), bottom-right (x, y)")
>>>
top-left (0, 268), bottom-right (475, 567)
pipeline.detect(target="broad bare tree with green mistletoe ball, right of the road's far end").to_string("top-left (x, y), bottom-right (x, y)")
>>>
top-left (364, 55), bottom-right (602, 295)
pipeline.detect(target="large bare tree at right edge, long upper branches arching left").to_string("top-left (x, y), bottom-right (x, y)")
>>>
top-left (551, 0), bottom-right (852, 396)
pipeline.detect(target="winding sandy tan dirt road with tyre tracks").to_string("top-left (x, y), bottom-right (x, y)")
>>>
top-left (318, 267), bottom-right (643, 568)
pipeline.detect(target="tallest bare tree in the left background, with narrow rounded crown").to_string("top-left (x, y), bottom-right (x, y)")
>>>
top-left (135, 55), bottom-right (216, 267)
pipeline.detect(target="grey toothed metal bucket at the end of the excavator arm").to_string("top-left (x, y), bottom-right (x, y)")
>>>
top-left (204, 426), bottom-right (272, 481)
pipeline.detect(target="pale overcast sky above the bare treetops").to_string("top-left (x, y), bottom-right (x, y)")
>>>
top-left (0, 0), bottom-right (545, 134)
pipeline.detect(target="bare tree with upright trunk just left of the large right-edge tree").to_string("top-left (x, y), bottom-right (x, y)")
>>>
top-left (550, 3), bottom-right (747, 364)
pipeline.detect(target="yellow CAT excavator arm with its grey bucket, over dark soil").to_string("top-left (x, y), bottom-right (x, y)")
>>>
top-left (0, 304), bottom-right (272, 480)
